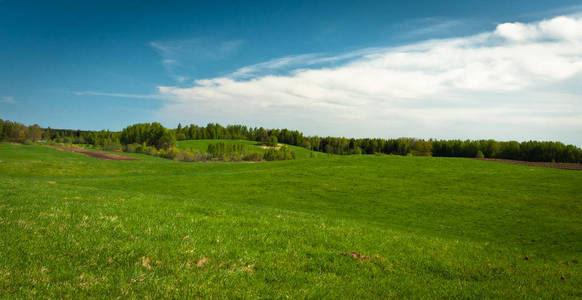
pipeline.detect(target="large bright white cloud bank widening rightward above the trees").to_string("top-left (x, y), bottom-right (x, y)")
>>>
top-left (154, 16), bottom-right (582, 145)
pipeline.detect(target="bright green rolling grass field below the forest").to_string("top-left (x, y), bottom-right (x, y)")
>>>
top-left (0, 141), bottom-right (582, 299)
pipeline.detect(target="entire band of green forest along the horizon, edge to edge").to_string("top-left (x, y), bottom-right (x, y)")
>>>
top-left (0, 120), bottom-right (582, 163)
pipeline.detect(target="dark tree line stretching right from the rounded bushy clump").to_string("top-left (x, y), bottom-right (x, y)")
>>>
top-left (175, 123), bottom-right (582, 163)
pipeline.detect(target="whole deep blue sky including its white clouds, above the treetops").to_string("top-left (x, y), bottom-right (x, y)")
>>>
top-left (0, 0), bottom-right (582, 145)
